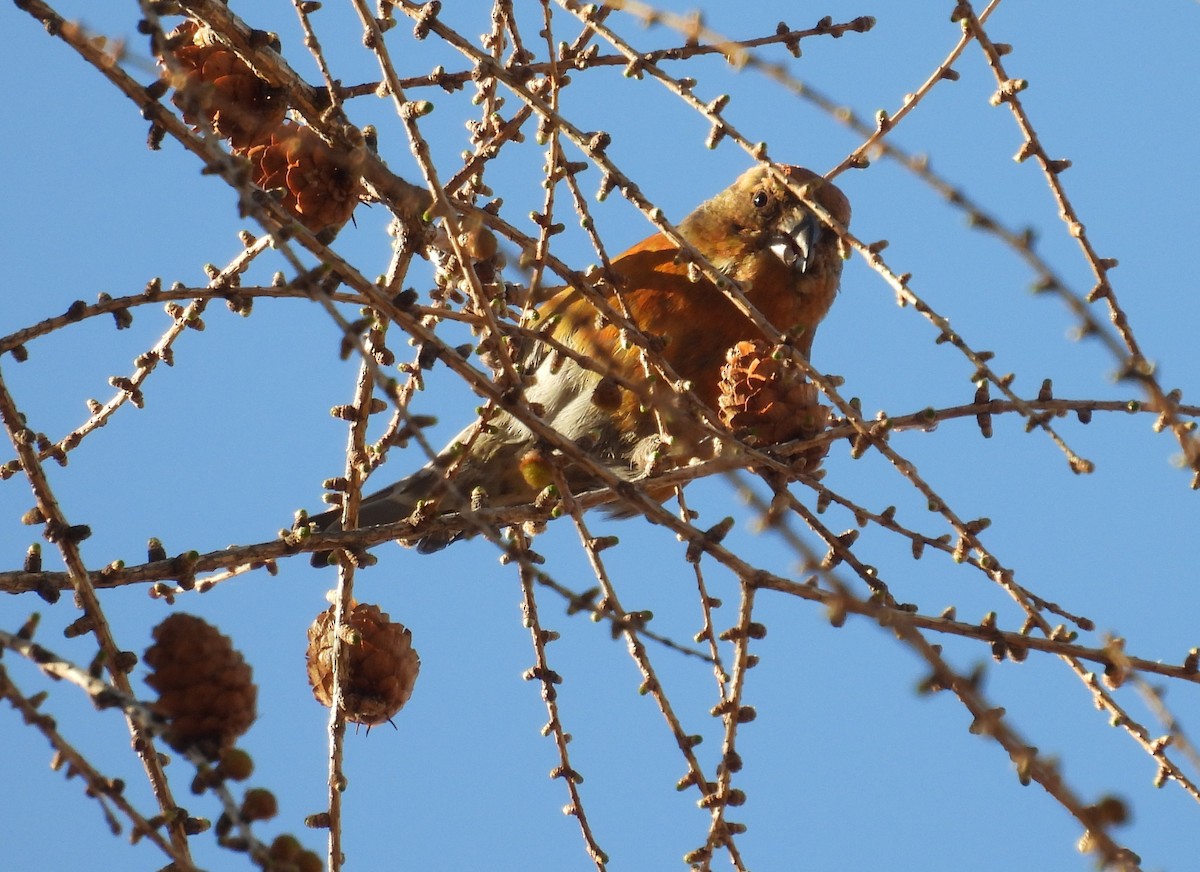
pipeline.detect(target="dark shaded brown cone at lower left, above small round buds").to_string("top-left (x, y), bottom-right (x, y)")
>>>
top-left (145, 612), bottom-right (258, 759)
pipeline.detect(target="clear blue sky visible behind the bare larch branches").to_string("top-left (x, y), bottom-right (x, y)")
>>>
top-left (0, 0), bottom-right (1200, 871)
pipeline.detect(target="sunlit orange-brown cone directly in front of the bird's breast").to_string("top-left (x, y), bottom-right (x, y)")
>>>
top-left (716, 341), bottom-right (829, 468)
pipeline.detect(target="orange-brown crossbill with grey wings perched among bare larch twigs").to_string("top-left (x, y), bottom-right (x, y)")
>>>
top-left (307, 164), bottom-right (850, 565)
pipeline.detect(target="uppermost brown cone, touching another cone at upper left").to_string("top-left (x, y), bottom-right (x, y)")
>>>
top-left (160, 22), bottom-right (288, 149)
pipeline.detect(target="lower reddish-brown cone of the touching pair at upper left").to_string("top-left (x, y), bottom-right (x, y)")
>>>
top-left (242, 121), bottom-right (362, 233)
